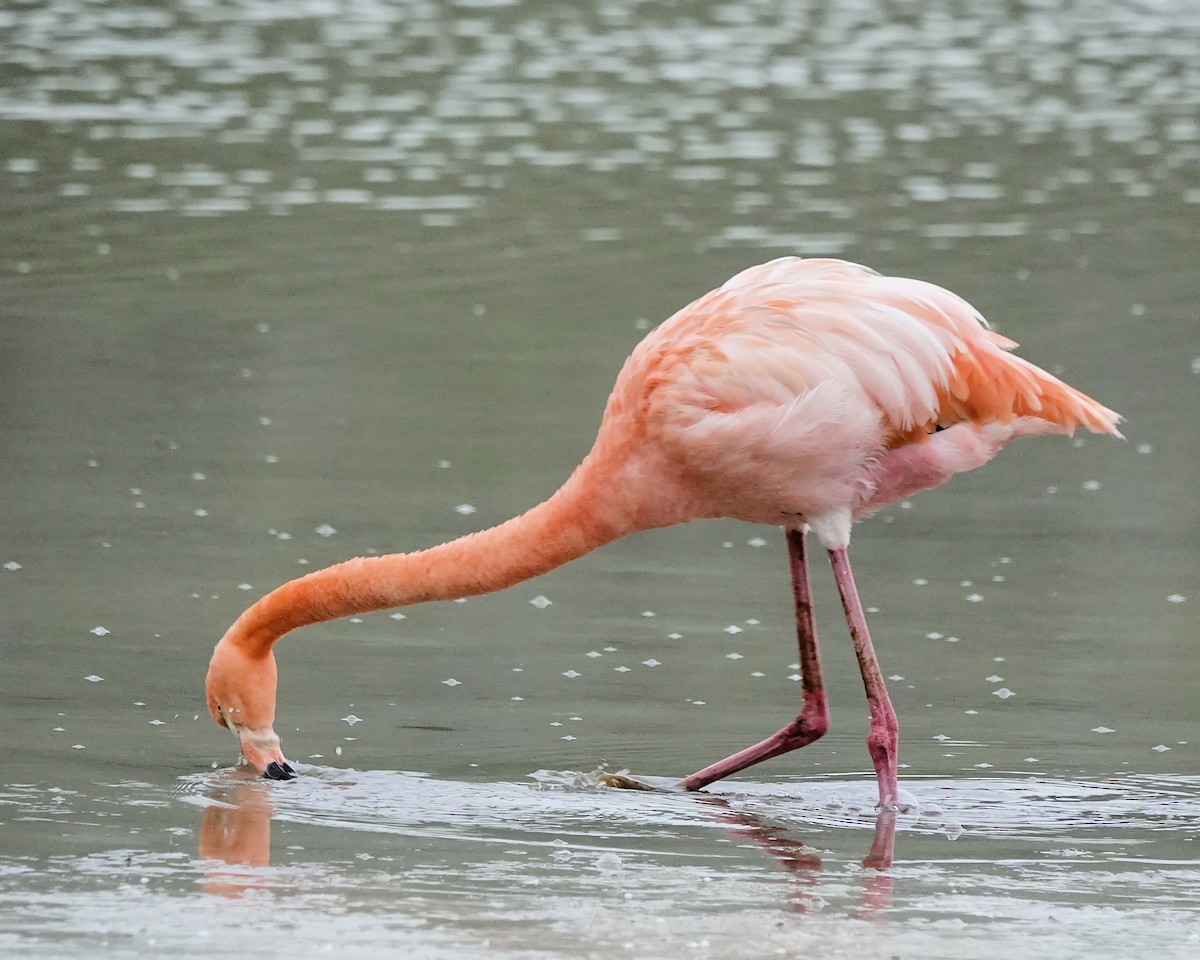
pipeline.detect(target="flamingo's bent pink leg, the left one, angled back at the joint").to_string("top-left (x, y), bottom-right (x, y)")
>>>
top-left (679, 530), bottom-right (829, 790)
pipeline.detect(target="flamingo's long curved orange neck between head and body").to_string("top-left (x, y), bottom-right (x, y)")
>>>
top-left (224, 456), bottom-right (660, 656)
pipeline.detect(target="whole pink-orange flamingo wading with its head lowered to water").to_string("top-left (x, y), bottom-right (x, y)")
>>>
top-left (206, 257), bottom-right (1121, 809)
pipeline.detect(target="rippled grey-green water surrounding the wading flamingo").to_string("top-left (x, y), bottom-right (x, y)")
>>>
top-left (0, 1), bottom-right (1200, 958)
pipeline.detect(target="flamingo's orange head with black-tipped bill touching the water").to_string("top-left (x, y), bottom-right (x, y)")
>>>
top-left (204, 638), bottom-right (296, 780)
